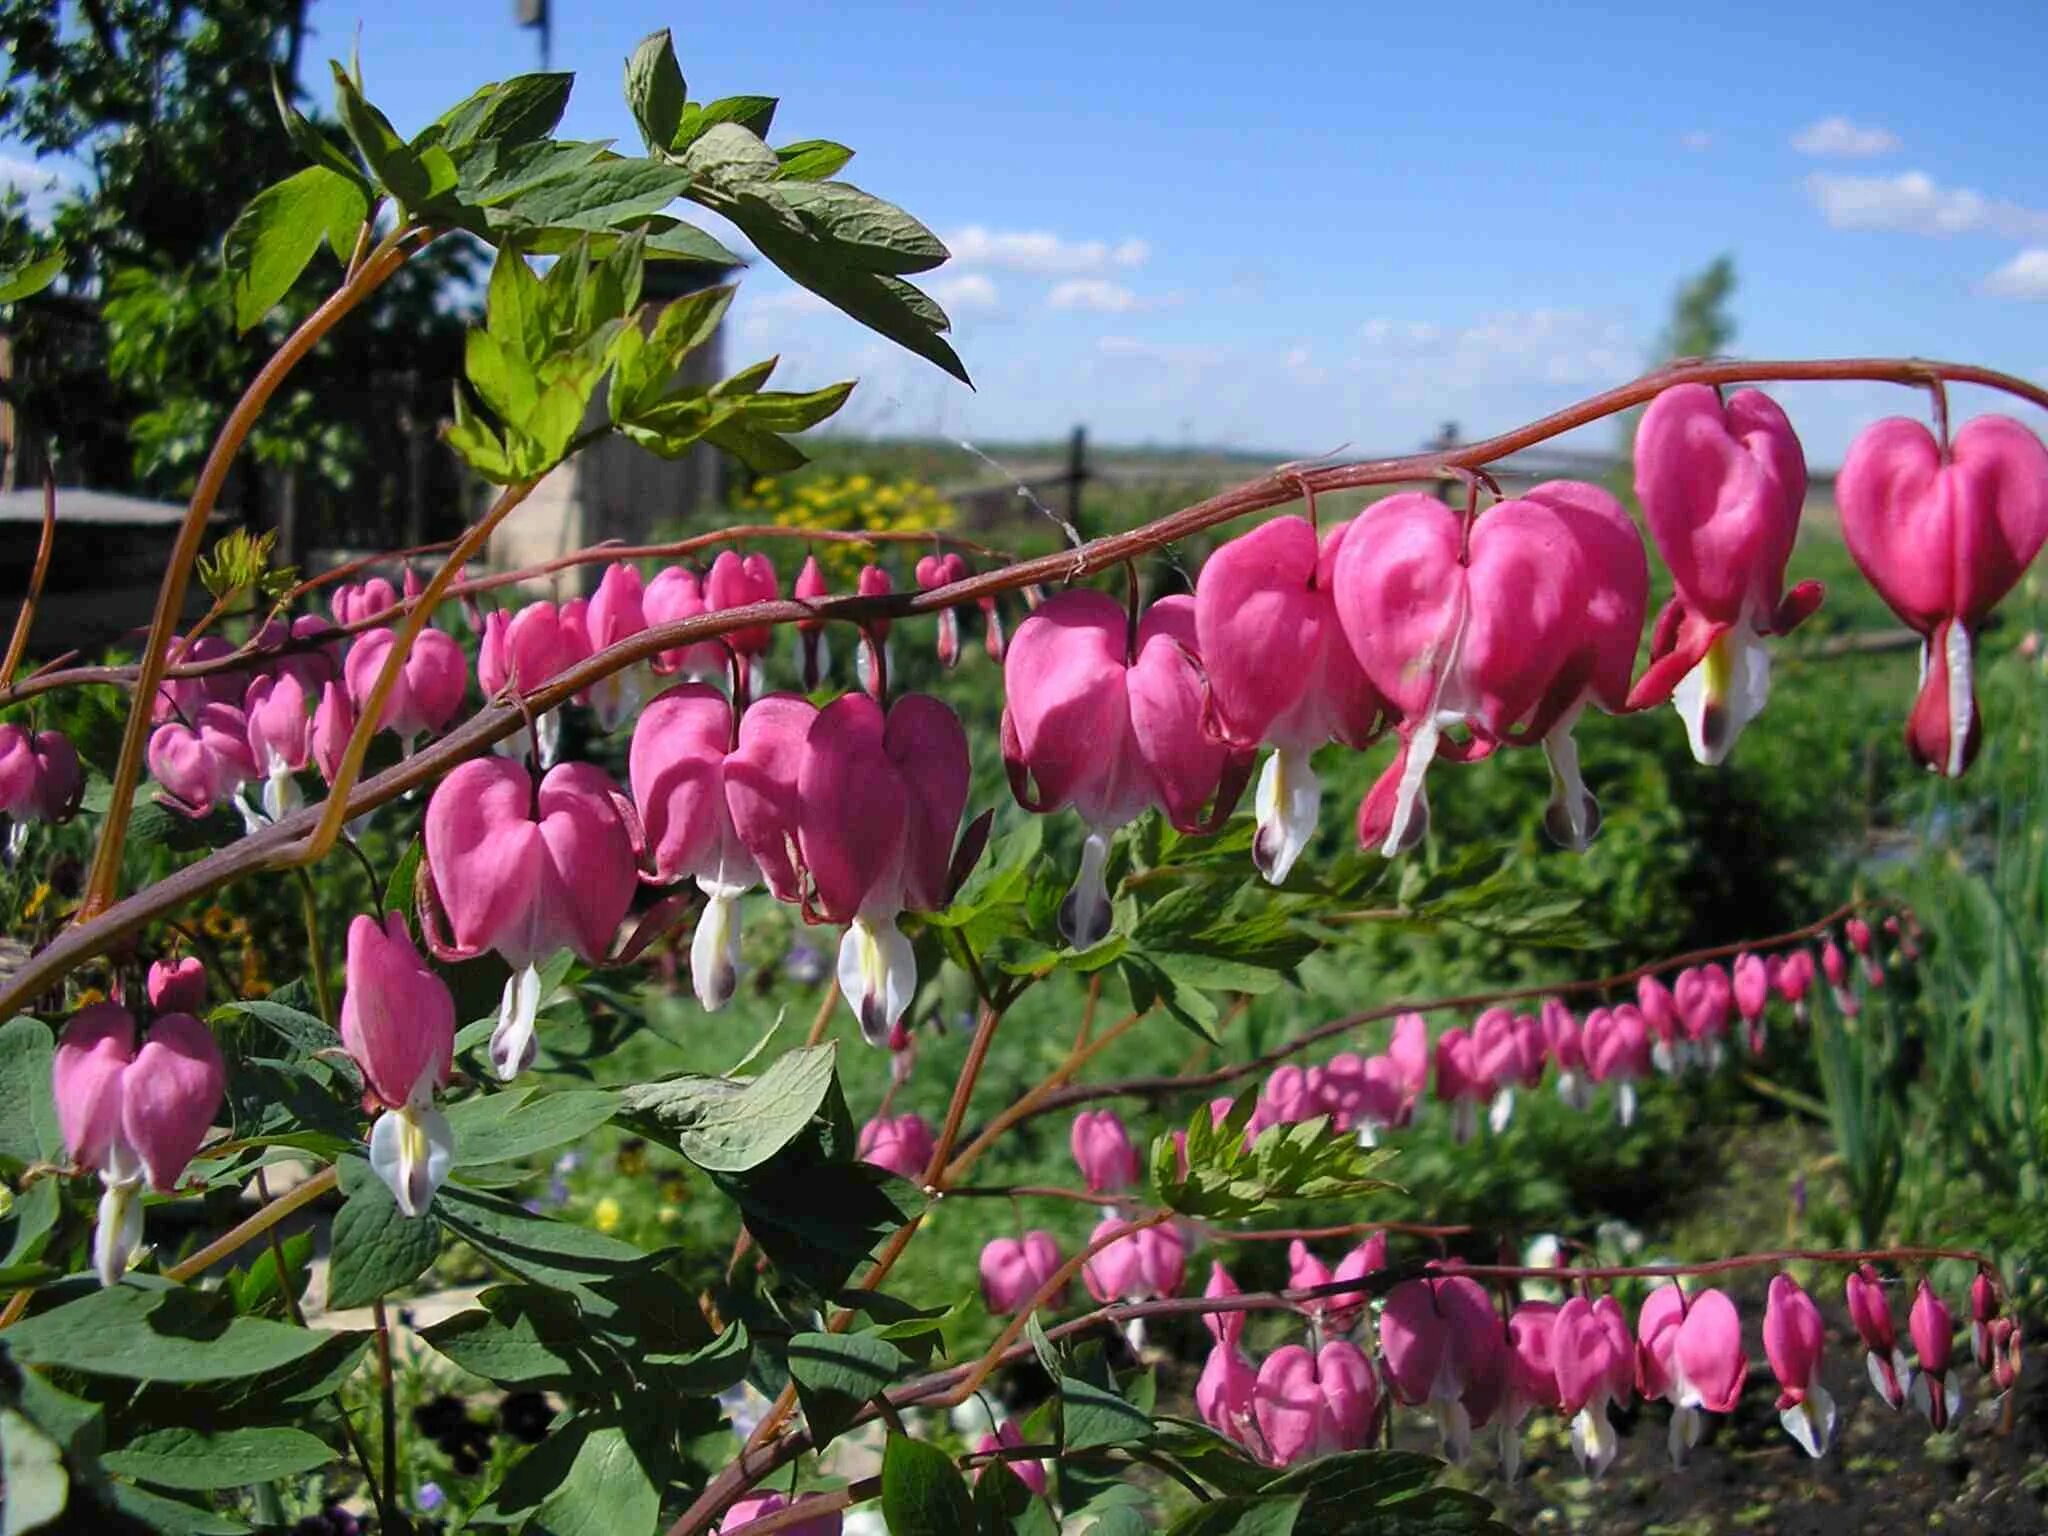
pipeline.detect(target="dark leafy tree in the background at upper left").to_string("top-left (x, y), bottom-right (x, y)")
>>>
top-left (0, 0), bottom-right (475, 543)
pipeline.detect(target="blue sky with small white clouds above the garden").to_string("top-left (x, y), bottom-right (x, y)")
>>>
top-left (16, 0), bottom-right (2048, 463)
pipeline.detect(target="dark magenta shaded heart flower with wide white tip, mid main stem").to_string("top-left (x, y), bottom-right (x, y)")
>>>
top-left (797, 694), bottom-right (969, 1044)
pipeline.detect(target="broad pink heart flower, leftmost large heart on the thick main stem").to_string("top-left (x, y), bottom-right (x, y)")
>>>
top-left (420, 758), bottom-right (639, 1081)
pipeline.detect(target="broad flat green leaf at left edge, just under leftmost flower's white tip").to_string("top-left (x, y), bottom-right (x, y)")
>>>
top-left (6, 1280), bottom-right (334, 1382)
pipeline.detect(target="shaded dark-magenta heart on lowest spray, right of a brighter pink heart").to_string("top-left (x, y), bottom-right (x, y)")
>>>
top-left (1380, 1276), bottom-right (1507, 1462)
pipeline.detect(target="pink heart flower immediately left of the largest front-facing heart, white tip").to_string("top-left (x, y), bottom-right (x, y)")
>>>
top-left (1194, 518), bottom-right (1386, 885)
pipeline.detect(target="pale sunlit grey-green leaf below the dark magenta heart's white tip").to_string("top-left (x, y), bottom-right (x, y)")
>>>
top-left (621, 1044), bottom-right (838, 1174)
